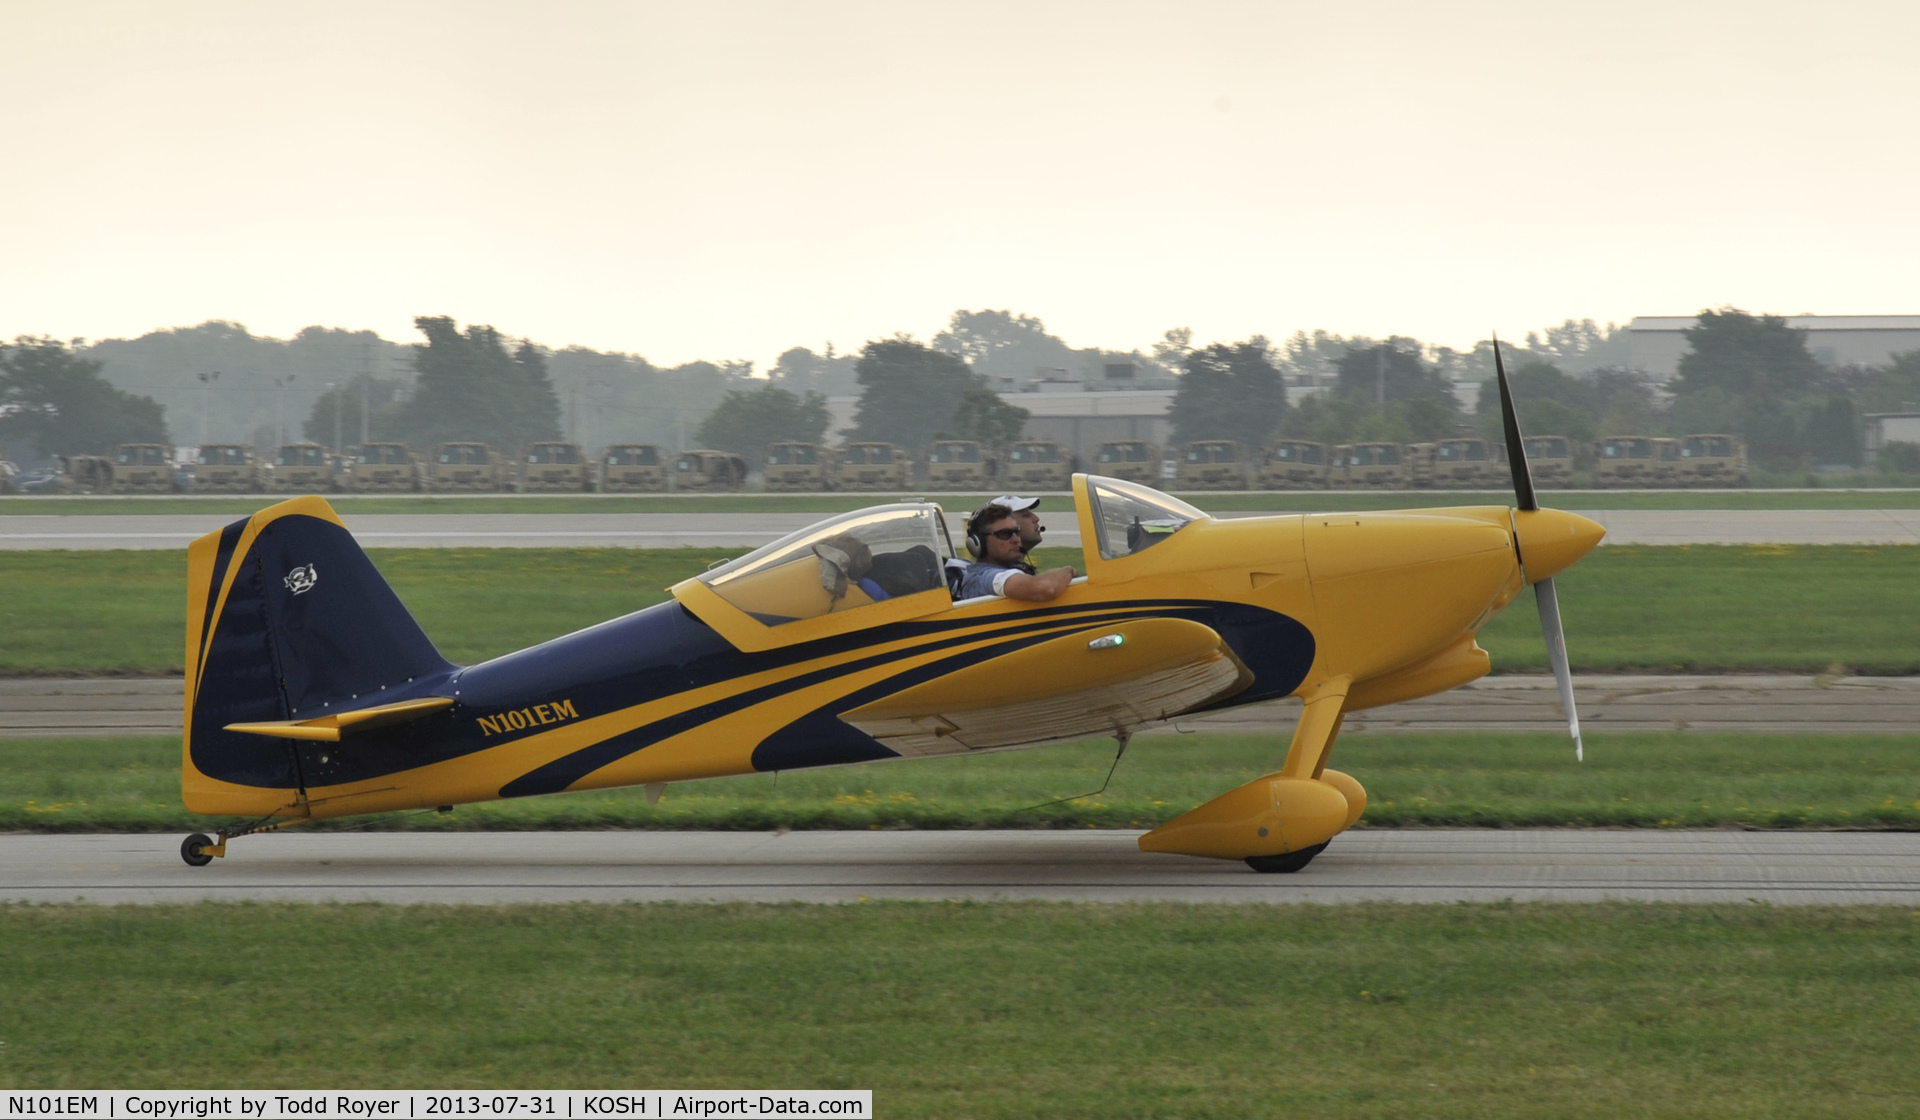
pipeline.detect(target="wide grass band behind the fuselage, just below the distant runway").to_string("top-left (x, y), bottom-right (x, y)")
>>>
top-left (0, 546), bottom-right (1920, 676)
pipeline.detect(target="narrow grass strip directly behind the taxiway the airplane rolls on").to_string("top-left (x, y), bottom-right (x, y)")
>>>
top-left (0, 726), bottom-right (1920, 832)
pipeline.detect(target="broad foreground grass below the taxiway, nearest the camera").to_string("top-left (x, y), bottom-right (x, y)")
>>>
top-left (0, 903), bottom-right (1920, 1120)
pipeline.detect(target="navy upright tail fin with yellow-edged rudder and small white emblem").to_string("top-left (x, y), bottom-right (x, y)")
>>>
top-left (182, 498), bottom-right (455, 813)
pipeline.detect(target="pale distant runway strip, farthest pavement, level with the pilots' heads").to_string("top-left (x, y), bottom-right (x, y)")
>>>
top-left (0, 501), bottom-right (1920, 549)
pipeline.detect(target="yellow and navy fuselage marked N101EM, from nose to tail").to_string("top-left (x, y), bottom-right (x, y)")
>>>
top-left (186, 494), bottom-right (1599, 816)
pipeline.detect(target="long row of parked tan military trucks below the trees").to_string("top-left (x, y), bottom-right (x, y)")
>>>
top-left (7, 434), bottom-right (1747, 494)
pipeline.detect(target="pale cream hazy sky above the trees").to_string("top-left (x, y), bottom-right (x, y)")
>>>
top-left (0, 0), bottom-right (1920, 369)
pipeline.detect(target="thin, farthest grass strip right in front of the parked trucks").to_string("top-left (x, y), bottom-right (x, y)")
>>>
top-left (0, 488), bottom-right (1920, 517)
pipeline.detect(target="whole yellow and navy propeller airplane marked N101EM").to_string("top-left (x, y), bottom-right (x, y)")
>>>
top-left (180, 344), bottom-right (1605, 872)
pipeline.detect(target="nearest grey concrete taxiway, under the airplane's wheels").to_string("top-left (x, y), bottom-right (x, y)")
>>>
top-left (0, 830), bottom-right (1920, 907)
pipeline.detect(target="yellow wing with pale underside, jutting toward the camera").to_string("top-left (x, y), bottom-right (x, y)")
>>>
top-left (841, 619), bottom-right (1254, 755)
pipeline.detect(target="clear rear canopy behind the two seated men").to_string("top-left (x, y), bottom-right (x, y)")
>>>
top-left (699, 501), bottom-right (952, 626)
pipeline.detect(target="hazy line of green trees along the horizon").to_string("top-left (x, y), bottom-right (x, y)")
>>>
top-left (0, 307), bottom-right (1920, 471)
